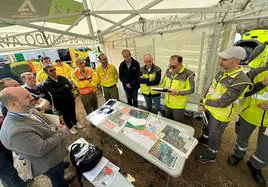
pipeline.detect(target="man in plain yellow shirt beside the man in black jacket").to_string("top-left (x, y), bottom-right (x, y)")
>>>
top-left (97, 53), bottom-right (119, 101)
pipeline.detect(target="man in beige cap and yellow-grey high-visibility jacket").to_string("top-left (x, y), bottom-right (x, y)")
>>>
top-left (197, 46), bottom-right (252, 163)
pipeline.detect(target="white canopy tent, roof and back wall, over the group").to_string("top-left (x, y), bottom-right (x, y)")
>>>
top-left (0, 0), bottom-right (268, 103)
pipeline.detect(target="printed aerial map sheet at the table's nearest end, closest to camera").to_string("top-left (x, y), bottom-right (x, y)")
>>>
top-left (149, 139), bottom-right (179, 168)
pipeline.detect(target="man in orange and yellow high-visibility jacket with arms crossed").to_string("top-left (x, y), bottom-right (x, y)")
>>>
top-left (71, 58), bottom-right (98, 114)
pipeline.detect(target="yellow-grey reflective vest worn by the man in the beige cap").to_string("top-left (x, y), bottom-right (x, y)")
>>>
top-left (203, 68), bottom-right (251, 122)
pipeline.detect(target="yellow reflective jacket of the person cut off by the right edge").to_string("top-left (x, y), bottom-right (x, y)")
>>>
top-left (240, 67), bottom-right (268, 127)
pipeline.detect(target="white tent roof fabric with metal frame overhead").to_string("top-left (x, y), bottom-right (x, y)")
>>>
top-left (0, 0), bottom-right (268, 50)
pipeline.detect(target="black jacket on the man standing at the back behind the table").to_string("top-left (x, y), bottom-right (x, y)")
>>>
top-left (119, 58), bottom-right (140, 90)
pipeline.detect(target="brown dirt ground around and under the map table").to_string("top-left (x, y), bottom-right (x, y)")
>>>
top-left (4, 90), bottom-right (268, 187)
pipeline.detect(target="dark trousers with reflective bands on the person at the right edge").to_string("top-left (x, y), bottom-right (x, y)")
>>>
top-left (234, 117), bottom-right (268, 170)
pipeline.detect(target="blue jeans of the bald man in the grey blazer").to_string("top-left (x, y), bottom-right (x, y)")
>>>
top-left (45, 162), bottom-right (69, 187)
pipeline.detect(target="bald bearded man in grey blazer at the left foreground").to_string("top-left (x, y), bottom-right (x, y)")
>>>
top-left (0, 87), bottom-right (68, 187)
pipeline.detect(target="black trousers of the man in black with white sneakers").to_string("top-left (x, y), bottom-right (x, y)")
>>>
top-left (59, 98), bottom-right (77, 129)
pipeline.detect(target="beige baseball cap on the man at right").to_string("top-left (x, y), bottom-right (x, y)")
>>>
top-left (218, 46), bottom-right (247, 60)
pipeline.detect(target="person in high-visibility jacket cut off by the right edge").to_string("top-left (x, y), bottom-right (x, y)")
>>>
top-left (227, 66), bottom-right (268, 186)
